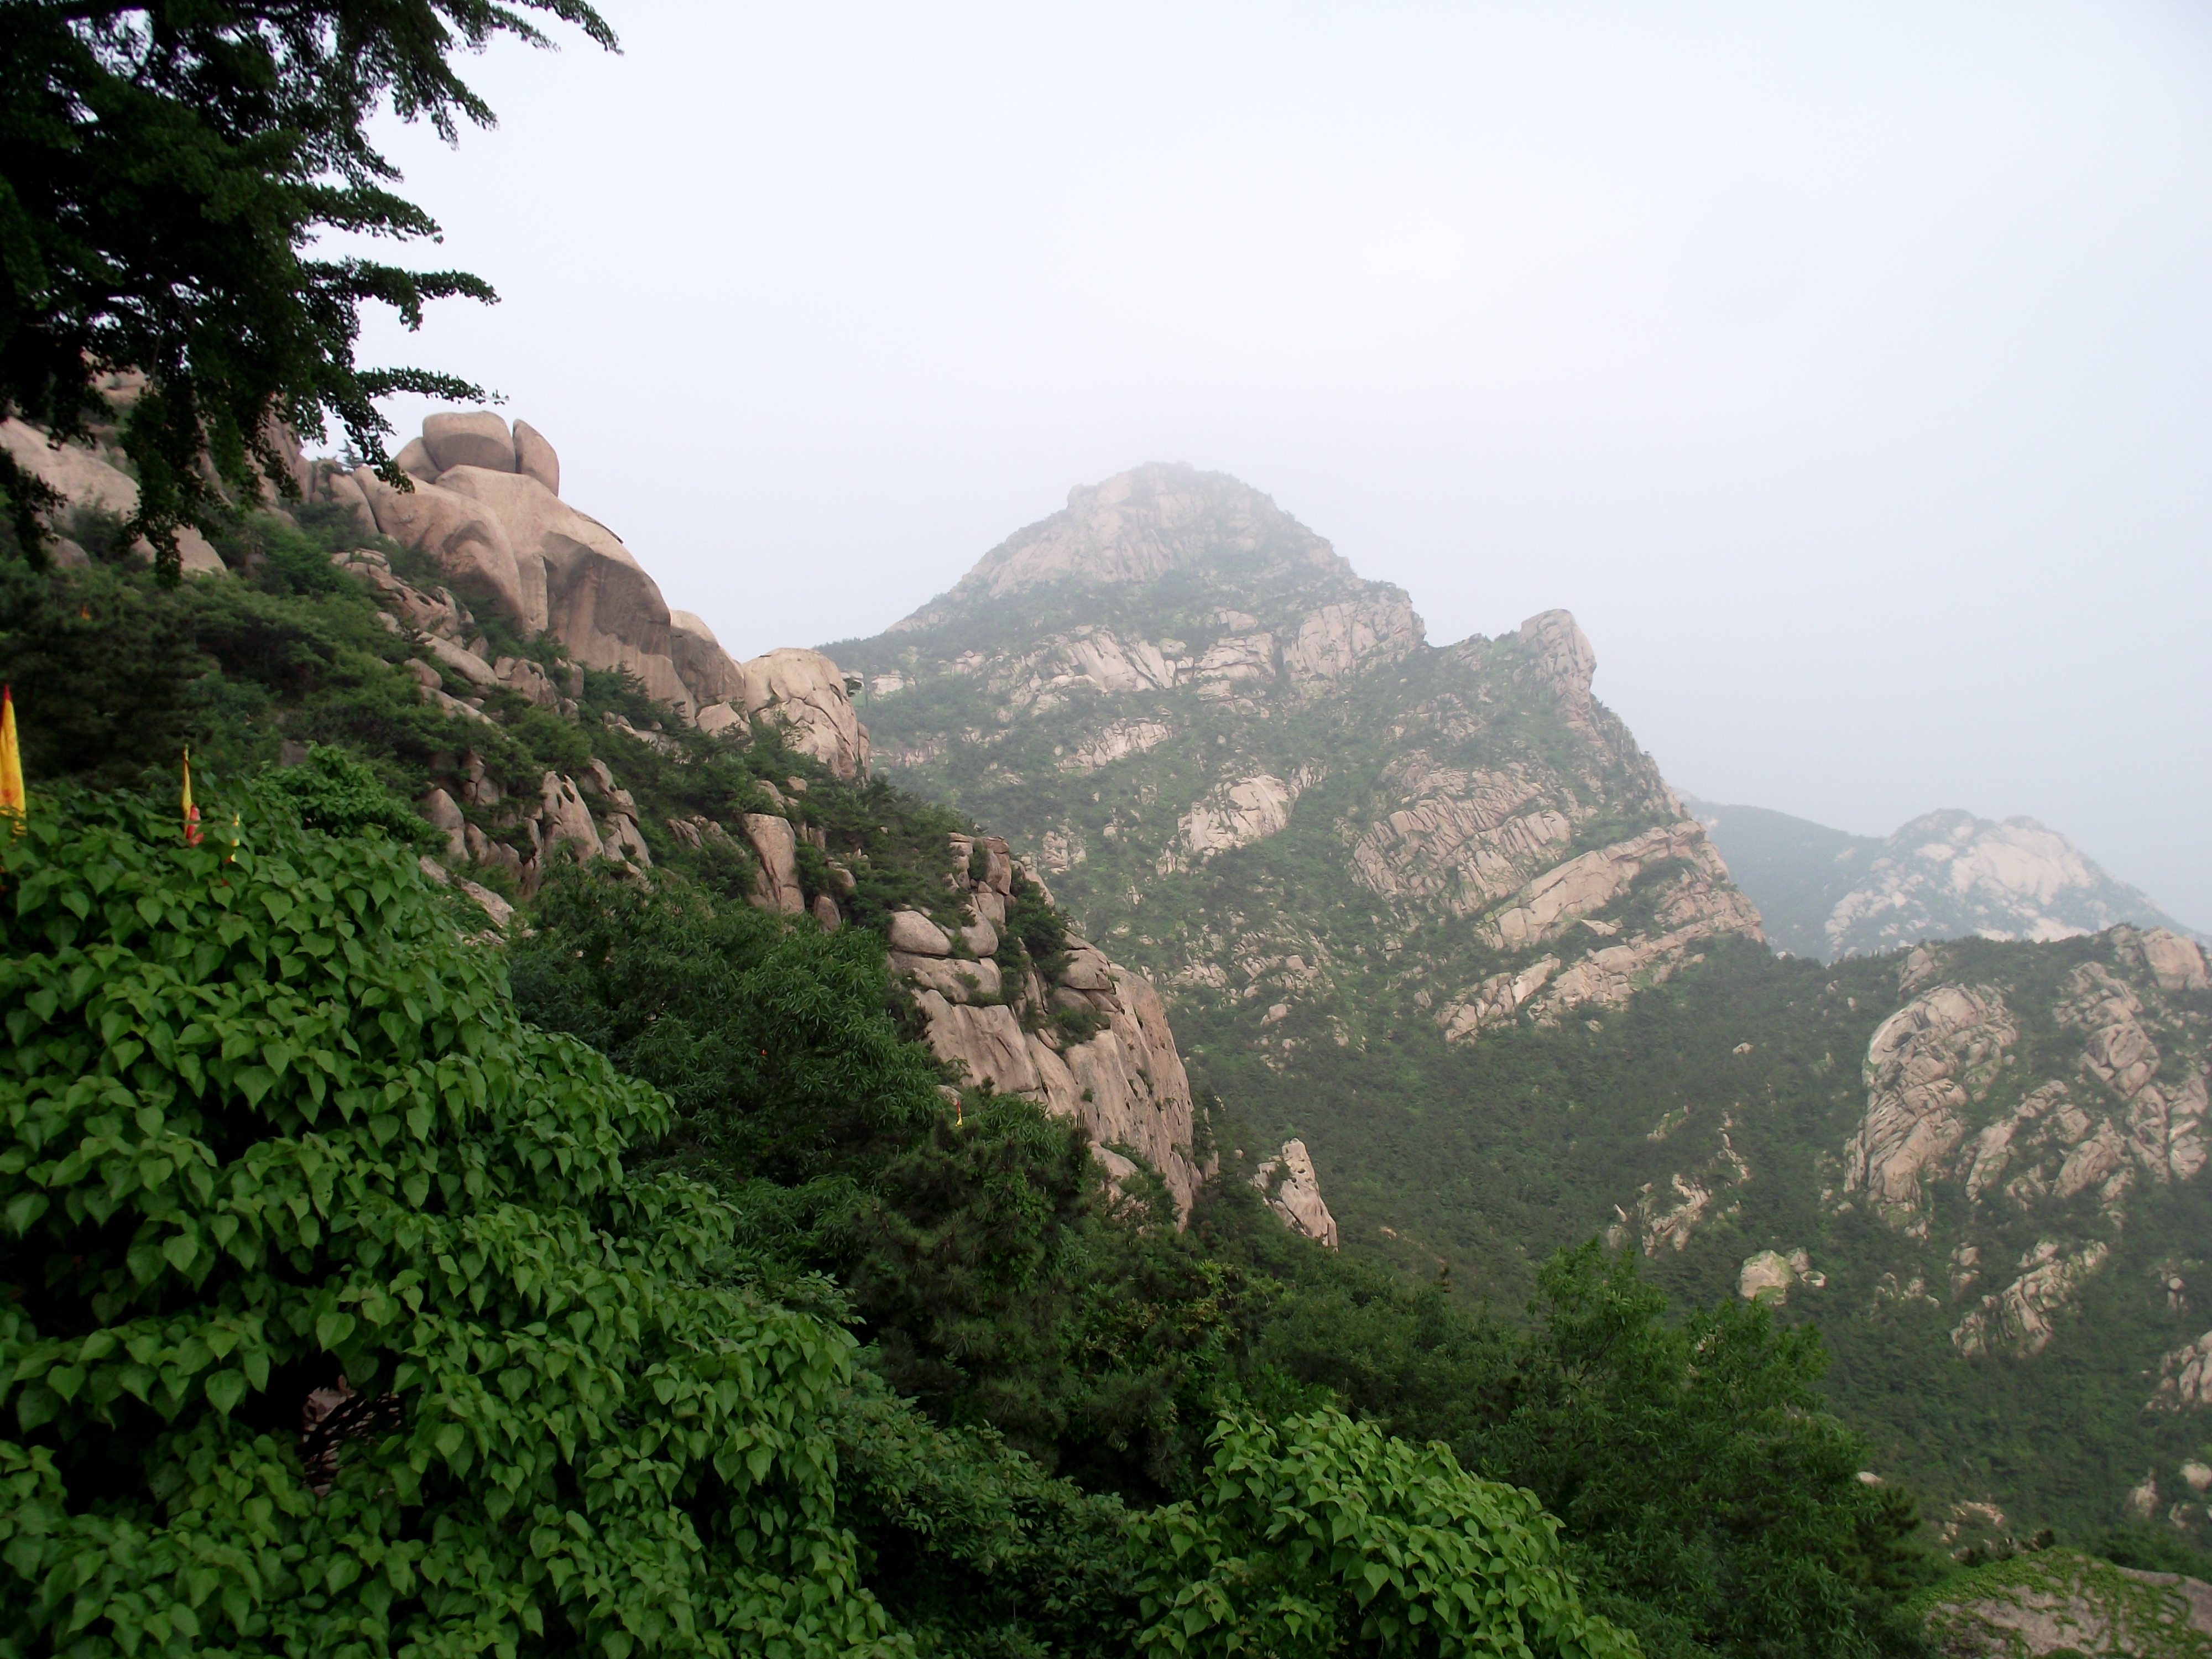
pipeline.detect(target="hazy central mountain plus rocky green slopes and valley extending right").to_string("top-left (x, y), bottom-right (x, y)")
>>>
top-left (832, 467), bottom-right (2212, 1546)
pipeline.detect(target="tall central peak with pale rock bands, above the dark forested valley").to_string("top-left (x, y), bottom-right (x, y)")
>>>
top-left (832, 467), bottom-right (1759, 1106)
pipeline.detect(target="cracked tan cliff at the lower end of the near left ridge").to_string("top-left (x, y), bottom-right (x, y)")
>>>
top-left (889, 836), bottom-right (1210, 1223)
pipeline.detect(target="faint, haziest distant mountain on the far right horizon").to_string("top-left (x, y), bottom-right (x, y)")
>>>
top-left (1683, 794), bottom-right (2192, 962)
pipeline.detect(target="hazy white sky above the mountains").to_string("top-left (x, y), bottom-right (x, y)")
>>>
top-left (363, 0), bottom-right (2212, 927)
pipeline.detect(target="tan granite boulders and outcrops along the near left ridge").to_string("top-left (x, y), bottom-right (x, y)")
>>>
top-left (0, 411), bottom-right (1212, 1221)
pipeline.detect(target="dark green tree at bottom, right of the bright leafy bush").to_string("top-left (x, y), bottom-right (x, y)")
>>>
top-left (1475, 1243), bottom-right (1918, 1655)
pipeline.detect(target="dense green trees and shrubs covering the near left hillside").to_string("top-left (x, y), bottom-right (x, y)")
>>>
top-left (0, 524), bottom-right (1955, 1655)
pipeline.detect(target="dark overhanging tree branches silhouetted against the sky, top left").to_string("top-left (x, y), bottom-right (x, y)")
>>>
top-left (0, 0), bottom-right (615, 575)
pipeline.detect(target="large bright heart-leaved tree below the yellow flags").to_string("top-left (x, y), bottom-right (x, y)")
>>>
top-left (0, 803), bottom-right (907, 1659)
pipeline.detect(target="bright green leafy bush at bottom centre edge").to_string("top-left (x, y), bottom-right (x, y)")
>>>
top-left (1137, 1411), bottom-right (1637, 1659)
